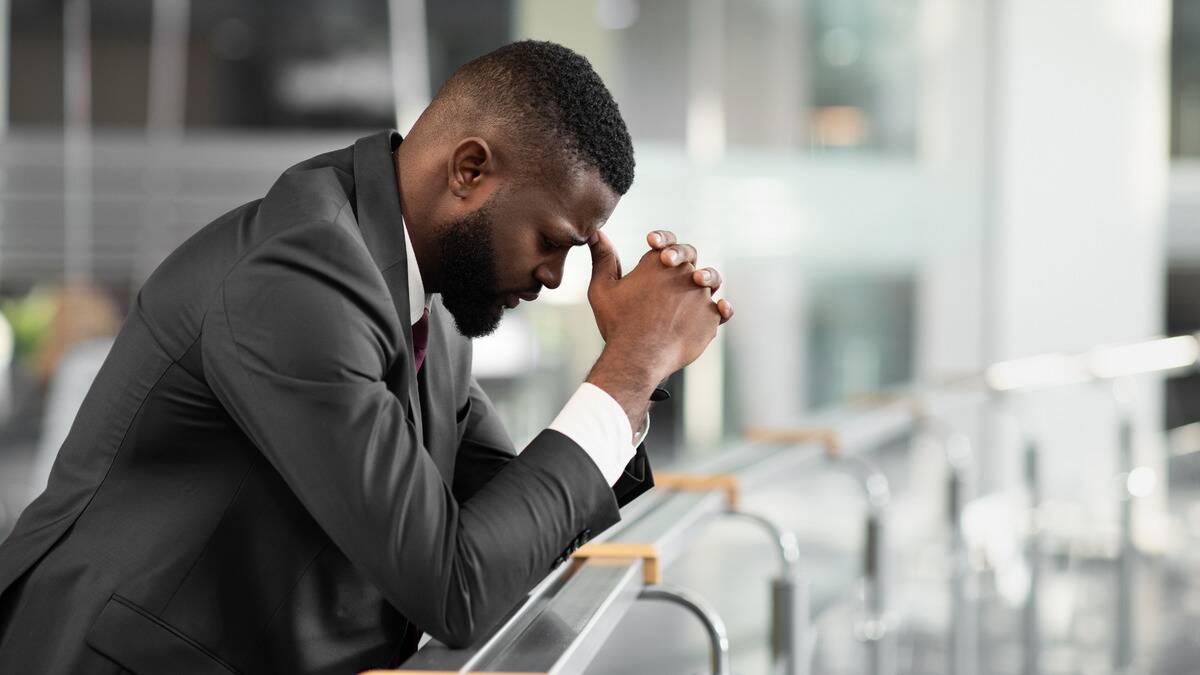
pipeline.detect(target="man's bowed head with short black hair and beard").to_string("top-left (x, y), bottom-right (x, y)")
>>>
top-left (397, 41), bottom-right (634, 338)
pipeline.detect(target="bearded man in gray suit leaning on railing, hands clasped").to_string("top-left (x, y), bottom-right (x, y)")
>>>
top-left (0, 42), bottom-right (732, 674)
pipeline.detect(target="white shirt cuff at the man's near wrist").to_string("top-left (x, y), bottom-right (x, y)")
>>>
top-left (550, 382), bottom-right (637, 485)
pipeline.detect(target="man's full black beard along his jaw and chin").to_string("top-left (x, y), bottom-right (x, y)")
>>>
top-left (438, 204), bottom-right (504, 338)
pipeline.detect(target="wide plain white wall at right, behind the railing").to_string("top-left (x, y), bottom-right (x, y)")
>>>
top-left (985, 0), bottom-right (1170, 510)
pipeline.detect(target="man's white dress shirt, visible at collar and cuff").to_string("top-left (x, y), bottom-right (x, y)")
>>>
top-left (403, 218), bottom-right (649, 485)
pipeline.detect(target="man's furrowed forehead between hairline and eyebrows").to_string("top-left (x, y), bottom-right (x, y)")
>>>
top-left (510, 163), bottom-right (620, 238)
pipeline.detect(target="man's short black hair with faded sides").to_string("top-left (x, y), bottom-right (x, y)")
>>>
top-left (436, 40), bottom-right (634, 195)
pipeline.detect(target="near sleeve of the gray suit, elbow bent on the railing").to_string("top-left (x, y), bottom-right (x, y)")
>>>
top-left (202, 219), bottom-right (619, 646)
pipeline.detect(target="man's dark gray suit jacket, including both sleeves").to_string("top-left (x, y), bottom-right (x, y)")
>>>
top-left (0, 132), bottom-right (652, 675)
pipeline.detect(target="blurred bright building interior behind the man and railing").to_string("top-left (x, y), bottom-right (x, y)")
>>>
top-left (0, 0), bottom-right (1200, 674)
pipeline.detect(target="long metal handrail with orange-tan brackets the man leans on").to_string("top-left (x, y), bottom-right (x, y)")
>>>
top-left (401, 336), bottom-right (1200, 673)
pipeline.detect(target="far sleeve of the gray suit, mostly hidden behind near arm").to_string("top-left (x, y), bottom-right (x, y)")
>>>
top-left (454, 378), bottom-right (654, 506)
